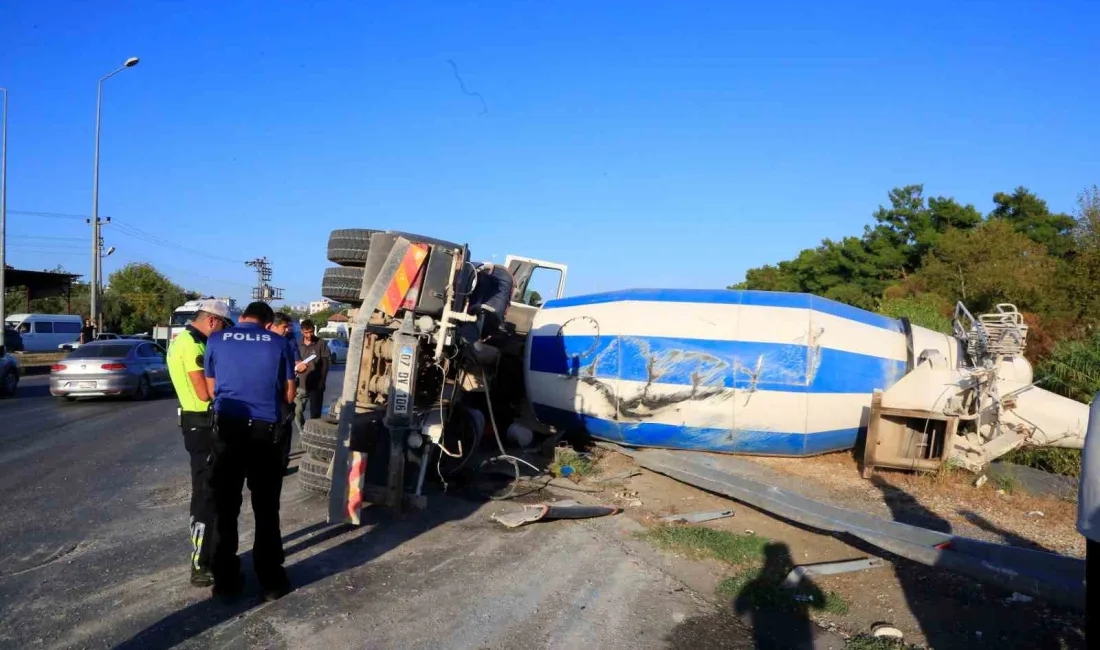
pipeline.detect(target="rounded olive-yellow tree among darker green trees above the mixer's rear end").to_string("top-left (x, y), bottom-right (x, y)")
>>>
top-left (920, 219), bottom-right (1056, 312)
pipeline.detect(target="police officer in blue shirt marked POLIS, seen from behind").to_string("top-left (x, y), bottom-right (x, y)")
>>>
top-left (204, 302), bottom-right (295, 601)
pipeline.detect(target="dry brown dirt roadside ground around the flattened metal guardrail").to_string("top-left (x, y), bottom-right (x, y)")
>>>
top-left (580, 450), bottom-right (1085, 650)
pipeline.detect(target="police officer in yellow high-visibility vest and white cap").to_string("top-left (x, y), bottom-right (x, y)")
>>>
top-left (162, 300), bottom-right (233, 587)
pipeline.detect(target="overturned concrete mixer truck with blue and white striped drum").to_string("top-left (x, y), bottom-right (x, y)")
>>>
top-left (299, 230), bottom-right (1088, 522)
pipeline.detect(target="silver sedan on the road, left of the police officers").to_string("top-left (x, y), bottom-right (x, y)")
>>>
top-left (50, 339), bottom-right (172, 401)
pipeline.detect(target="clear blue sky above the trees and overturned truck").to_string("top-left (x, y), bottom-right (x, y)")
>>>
top-left (0, 0), bottom-right (1100, 301)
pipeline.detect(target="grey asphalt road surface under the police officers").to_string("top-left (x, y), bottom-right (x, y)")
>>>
top-left (0, 369), bottom-right (751, 649)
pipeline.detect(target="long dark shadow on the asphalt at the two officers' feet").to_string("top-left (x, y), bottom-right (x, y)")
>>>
top-left (116, 496), bottom-right (482, 650)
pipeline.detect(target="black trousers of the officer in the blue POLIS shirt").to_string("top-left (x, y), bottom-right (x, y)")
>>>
top-left (212, 417), bottom-right (286, 587)
